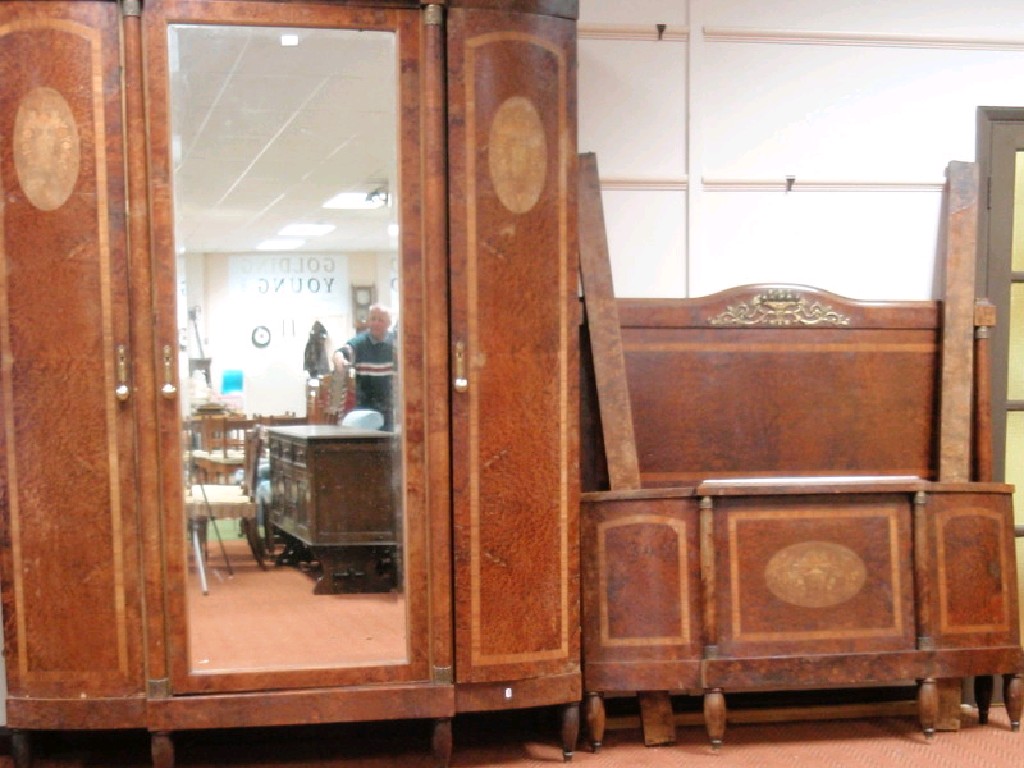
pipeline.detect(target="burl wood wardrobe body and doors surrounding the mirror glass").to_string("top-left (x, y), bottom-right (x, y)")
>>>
top-left (0, 0), bottom-right (582, 768)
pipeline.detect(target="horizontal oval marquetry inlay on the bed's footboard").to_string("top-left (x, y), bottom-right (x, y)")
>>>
top-left (765, 542), bottom-right (867, 608)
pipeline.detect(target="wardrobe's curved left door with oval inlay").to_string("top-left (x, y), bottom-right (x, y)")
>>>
top-left (0, 2), bottom-right (143, 704)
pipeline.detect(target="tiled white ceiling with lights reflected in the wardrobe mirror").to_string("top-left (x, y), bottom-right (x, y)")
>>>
top-left (169, 25), bottom-right (398, 253)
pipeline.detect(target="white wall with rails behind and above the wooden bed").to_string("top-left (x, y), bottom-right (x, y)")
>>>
top-left (579, 0), bottom-right (1024, 299)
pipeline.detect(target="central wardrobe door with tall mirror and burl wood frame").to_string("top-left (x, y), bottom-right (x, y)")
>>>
top-left (144, 2), bottom-right (431, 693)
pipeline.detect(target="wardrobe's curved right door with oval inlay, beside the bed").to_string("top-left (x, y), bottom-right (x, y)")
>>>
top-left (449, 7), bottom-right (579, 688)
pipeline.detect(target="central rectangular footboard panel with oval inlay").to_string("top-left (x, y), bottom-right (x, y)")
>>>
top-left (713, 495), bottom-right (915, 656)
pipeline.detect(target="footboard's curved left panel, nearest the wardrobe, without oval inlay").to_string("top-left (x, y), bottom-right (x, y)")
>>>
top-left (581, 490), bottom-right (703, 690)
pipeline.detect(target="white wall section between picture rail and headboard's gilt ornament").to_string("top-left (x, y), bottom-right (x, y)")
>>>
top-left (690, 184), bottom-right (940, 300)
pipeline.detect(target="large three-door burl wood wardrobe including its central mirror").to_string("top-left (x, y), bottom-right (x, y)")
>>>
top-left (0, 0), bottom-right (582, 768)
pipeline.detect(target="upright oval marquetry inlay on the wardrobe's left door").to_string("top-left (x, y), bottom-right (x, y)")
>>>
top-left (13, 87), bottom-right (81, 211)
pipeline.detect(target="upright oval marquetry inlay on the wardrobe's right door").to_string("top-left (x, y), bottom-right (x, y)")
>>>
top-left (487, 96), bottom-right (548, 213)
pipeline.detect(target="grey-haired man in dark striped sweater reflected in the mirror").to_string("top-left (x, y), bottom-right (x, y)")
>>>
top-left (338, 304), bottom-right (395, 431)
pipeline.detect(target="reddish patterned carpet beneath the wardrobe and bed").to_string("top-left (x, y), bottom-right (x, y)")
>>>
top-left (0, 708), bottom-right (1024, 768)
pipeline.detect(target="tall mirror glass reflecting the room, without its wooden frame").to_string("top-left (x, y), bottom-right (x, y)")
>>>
top-left (168, 25), bottom-right (409, 673)
